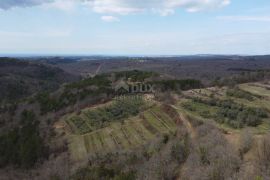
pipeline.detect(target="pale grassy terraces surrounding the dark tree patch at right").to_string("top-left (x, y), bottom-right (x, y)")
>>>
top-left (177, 83), bottom-right (270, 134)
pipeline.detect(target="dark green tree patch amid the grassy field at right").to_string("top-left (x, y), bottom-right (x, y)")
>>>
top-left (183, 98), bottom-right (268, 128)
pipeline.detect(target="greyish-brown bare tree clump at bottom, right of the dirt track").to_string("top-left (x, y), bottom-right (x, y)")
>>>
top-left (180, 124), bottom-right (241, 180)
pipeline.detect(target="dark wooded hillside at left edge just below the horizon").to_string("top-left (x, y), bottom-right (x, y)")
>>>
top-left (0, 58), bottom-right (78, 102)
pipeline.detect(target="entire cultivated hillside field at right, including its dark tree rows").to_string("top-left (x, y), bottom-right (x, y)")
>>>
top-left (177, 83), bottom-right (270, 134)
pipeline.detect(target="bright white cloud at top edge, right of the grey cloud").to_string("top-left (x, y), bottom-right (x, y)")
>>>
top-left (84, 0), bottom-right (230, 16)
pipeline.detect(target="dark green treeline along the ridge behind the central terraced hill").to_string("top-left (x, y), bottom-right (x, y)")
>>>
top-left (35, 70), bottom-right (202, 114)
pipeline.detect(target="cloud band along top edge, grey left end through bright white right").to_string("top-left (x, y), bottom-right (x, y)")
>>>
top-left (0, 0), bottom-right (230, 15)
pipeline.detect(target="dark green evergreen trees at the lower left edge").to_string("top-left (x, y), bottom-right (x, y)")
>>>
top-left (0, 110), bottom-right (48, 168)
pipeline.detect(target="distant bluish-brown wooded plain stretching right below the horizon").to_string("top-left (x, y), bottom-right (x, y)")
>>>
top-left (50, 55), bottom-right (270, 84)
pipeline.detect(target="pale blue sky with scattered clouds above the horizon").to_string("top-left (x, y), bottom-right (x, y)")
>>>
top-left (0, 0), bottom-right (270, 55)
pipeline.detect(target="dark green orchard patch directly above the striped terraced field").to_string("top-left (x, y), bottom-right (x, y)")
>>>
top-left (67, 96), bottom-right (146, 134)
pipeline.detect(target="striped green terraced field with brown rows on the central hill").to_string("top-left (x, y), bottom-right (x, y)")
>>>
top-left (67, 106), bottom-right (176, 161)
